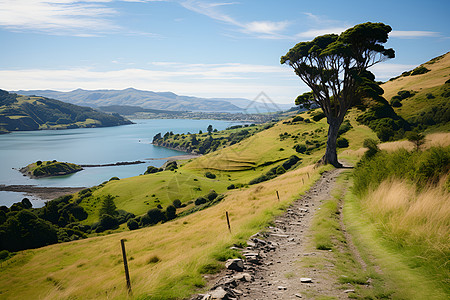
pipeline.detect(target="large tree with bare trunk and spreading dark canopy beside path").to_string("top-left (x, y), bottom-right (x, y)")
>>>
top-left (281, 22), bottom-right (395, 167)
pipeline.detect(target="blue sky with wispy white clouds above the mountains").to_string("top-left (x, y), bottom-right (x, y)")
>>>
top-left (0, 0), bottom-right (450, 104)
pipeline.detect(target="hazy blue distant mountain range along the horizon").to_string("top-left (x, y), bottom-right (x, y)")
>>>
top-left (14, 88), bottom-right (293, 113)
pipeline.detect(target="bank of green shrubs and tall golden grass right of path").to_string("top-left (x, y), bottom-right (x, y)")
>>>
top-left (354, 147), bottom-right (450, 292)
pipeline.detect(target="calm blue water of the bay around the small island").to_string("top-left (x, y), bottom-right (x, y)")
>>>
top-left (0, 119), bottom-right (237, 207)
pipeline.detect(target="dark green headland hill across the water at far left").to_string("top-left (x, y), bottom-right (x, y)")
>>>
top-left (0, 90), bottom-right (132, 133)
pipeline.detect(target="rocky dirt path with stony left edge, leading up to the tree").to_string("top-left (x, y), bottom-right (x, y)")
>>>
top-left (193, 169), bottom-right (353, 300)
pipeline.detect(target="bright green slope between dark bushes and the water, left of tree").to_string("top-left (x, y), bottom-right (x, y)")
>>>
top-left (76, 113), bottom-right (338, 224)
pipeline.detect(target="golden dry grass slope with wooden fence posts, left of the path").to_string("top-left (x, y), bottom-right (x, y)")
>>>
top-left (0, 166), bottom-right (319, 299)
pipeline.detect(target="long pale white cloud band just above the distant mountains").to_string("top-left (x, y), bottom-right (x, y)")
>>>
top-left (0, 62), bottom-right (306, 103)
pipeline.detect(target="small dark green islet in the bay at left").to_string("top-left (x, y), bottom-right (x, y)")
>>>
top-left (20, 160), bottom-right (83, 178)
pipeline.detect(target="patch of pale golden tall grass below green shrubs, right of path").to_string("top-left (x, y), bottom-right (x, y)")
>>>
top-left (363, 178), bottom-right (450, 254)
